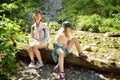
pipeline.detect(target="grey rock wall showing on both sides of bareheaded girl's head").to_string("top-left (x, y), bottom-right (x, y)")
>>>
top-left (25, 0), bottom-right (62, 24)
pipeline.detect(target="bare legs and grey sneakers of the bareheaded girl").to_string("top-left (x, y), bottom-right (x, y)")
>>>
top-left (29, 41), bottom-right (47, 68)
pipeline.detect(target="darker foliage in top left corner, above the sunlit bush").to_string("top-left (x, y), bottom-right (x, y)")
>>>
top-left (0, 0), bottom-right (38, 32)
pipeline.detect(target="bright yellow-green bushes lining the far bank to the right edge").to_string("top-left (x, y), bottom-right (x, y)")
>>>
top-left (75, 14), bottom-right (120, 32)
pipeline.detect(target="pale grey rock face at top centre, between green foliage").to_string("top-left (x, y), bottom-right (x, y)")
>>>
top-left (44, 0), bottom-right (63, 21)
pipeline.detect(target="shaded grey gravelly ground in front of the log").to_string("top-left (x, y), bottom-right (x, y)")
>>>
top-left (11, 65), bottom-right (109, 80)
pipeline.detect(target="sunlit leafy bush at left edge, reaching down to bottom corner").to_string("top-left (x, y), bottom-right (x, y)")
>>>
top-left (0, 17), bottom-right (25, 79)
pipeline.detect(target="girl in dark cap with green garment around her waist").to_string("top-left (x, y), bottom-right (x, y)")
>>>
top-left (52, 21), bottom-right (88, 80)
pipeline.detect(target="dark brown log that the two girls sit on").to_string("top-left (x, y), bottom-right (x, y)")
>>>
top-left (16, 49), bottom-right (120, 73)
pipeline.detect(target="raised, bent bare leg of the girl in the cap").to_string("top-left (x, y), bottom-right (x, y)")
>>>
top-left (68, 37), bottom-right (81, 53)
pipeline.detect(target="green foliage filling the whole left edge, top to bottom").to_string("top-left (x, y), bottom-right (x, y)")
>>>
top-left (0, 0), bottom-right (36, 80)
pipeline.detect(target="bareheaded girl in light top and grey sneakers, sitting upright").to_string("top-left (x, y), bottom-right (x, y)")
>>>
top-left (29, 11), bottom-right (49, 68)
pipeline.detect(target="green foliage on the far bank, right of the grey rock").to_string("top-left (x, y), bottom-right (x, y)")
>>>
top-left (58, 0), bottom-right (120, 32)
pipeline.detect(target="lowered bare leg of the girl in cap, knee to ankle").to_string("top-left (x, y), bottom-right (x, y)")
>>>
top-left (57, 49), bottom-right (64, 72)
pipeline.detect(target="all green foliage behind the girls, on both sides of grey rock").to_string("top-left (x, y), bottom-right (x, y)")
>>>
top-left (0, 0), bottom-right (120, 79)
